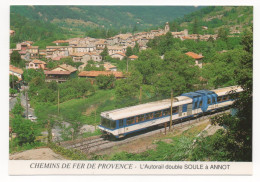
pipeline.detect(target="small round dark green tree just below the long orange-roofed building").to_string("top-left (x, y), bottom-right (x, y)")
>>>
top-left (96, 74), bottom-right (116, 89)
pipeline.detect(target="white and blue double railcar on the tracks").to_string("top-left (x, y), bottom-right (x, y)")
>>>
top-left (98, 86), bottom-right (243, 138)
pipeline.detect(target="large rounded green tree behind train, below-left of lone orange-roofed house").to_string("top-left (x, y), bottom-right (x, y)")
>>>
top-left (154, 50), bottom-right (199, 96)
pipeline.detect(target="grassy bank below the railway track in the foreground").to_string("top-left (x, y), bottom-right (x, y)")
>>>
top-left (91, 123), bottom-right (208, 161)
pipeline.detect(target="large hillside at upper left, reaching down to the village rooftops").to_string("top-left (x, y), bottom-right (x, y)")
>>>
top-left (10, 6), bottom-right (200, 48)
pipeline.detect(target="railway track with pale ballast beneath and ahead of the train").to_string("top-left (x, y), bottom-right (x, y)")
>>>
top-left (60, 110), bottom-right (230, 154)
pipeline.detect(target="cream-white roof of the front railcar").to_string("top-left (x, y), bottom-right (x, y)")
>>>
top-left (101, 96), bottom-right (192, 120)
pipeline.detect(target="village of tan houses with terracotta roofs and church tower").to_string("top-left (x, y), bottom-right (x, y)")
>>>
top-left (9, 22), bottom-right (217, 83)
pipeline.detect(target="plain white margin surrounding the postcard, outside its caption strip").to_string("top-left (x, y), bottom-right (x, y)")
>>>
top-left (0, 0), bottom-right (260, 182)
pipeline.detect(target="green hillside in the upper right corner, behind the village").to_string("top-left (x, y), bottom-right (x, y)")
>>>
top-left (170, 6), bottom-right (253, 34)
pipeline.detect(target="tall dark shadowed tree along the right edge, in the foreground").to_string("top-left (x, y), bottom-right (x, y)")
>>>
top-left (212, 30), bottom-right (253, 161)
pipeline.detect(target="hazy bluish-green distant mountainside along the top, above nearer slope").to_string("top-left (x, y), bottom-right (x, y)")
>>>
top-left (10, 6), bottom-right (201, 30)
